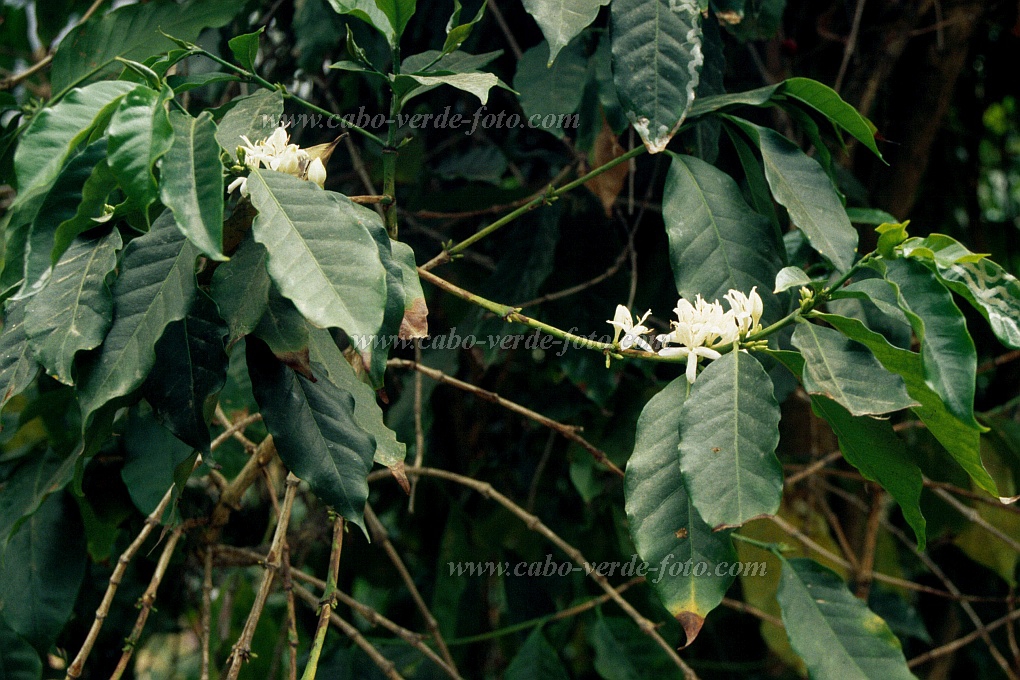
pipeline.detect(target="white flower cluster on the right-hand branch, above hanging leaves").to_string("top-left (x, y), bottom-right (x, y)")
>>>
top-left (607, 286), bottom-right (763, 382)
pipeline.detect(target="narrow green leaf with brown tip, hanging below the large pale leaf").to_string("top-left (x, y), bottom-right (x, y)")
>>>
top-left (308, 328), bottom-right (407, 469)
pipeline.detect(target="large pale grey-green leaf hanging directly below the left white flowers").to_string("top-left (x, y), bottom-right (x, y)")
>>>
top-left (248, 170), bottom-right (386, 337)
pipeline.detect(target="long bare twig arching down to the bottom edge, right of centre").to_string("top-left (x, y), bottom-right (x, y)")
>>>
top-left (369, 468), bottom-right (698, 680)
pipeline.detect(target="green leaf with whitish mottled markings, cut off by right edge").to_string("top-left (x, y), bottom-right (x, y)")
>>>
top-left (903, 233), bottom-right (1020, 350)
